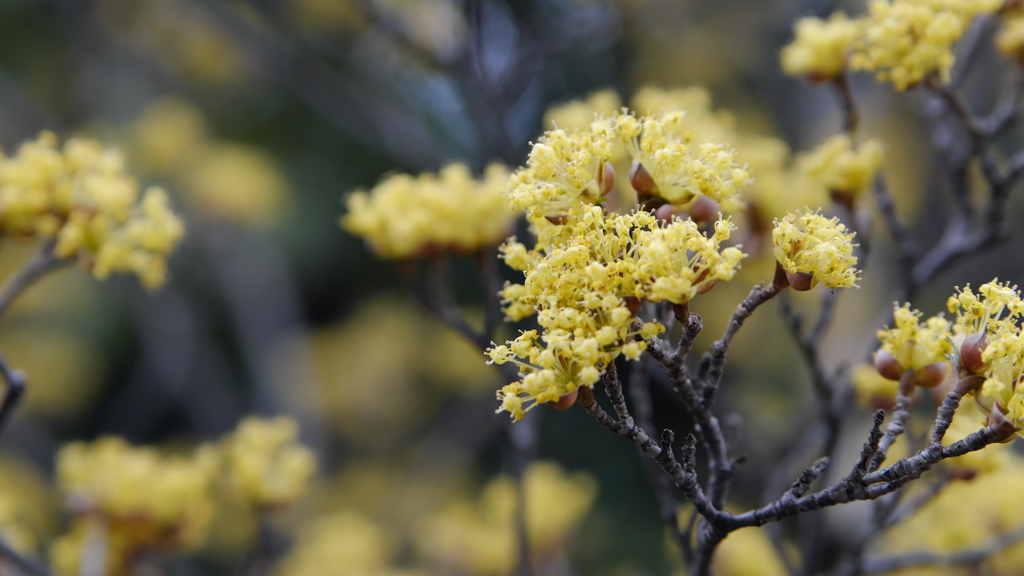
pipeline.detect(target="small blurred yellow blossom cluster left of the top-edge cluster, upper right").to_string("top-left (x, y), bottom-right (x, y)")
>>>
top-left (781, 12), bottom-right (859, 80)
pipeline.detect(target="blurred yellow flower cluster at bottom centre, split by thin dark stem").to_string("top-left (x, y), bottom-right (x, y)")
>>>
top-left (418, 461), bottom-right (597, 576)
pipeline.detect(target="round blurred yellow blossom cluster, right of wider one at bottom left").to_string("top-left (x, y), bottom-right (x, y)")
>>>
top-left (220, 417), bottom-right (316, 509)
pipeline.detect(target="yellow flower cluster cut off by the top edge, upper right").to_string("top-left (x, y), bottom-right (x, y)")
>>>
top-left (850, 0), bottom-right (1002, 90)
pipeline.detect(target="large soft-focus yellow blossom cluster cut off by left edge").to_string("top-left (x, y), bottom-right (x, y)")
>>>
top-left (0, 132), bottom-right (184, 288)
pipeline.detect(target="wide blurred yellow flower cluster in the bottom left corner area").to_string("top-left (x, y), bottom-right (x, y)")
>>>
top-left (52, 438), bottom-right (215, 574)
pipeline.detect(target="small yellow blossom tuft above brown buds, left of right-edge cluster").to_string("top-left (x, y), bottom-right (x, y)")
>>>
top-left (878, 304), bottom-right (953, 379)
